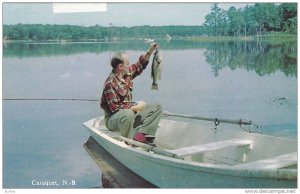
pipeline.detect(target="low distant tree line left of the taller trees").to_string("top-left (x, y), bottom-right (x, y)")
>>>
top-left (3, 24), bottom-right (203, 40)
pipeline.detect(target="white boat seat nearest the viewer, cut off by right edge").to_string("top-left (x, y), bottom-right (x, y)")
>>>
top-left (234, 152), bottom-right (297, 169)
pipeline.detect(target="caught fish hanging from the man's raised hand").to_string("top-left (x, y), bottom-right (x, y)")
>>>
top-left (151, 49), bottom-right (162, 90)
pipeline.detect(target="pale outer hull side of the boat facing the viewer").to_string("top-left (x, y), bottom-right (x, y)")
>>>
top-left (83, 117), bottom-right (297, 188)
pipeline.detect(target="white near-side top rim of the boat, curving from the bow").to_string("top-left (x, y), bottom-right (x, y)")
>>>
top-left (83, 117), bottom-right (297, 180)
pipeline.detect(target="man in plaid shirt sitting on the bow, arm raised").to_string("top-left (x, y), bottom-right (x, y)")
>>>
top-left (100, 43), bottom-right (162, 143)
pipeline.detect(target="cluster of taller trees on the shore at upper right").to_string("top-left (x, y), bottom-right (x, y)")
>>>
top-left (204, 3), bottom-right (297, 36)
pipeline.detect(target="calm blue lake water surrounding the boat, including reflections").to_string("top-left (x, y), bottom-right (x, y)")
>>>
top-left (2, 40), bottom-right (297, 188)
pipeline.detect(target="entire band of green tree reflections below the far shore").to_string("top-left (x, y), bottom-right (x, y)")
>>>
top-left (3, 40), bottom-right (297, 77)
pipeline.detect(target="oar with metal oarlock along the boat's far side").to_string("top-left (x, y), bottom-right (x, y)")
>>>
top-left (163, 111), bottom-right (253, 125)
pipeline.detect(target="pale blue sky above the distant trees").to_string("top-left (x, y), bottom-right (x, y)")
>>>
top-left (2, 2), bottom-right (252, 27)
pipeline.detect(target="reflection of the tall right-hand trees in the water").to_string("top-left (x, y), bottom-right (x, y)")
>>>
top-left (205, 41), bottom-right (297, 77)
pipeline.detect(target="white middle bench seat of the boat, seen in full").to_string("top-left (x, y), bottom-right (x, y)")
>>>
top-left (168, 139), bottom-right (252, 156)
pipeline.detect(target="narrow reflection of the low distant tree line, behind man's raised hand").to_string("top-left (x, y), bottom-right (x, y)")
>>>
top-left (3, 40), bottom-right (209, 58)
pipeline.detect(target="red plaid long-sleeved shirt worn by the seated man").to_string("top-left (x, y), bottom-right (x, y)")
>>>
top-left (100, 55), bottom-right (149, 115)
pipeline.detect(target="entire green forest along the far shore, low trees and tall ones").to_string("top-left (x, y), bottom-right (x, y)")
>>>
top-left (3, 3), bottom-right (297, 41)
